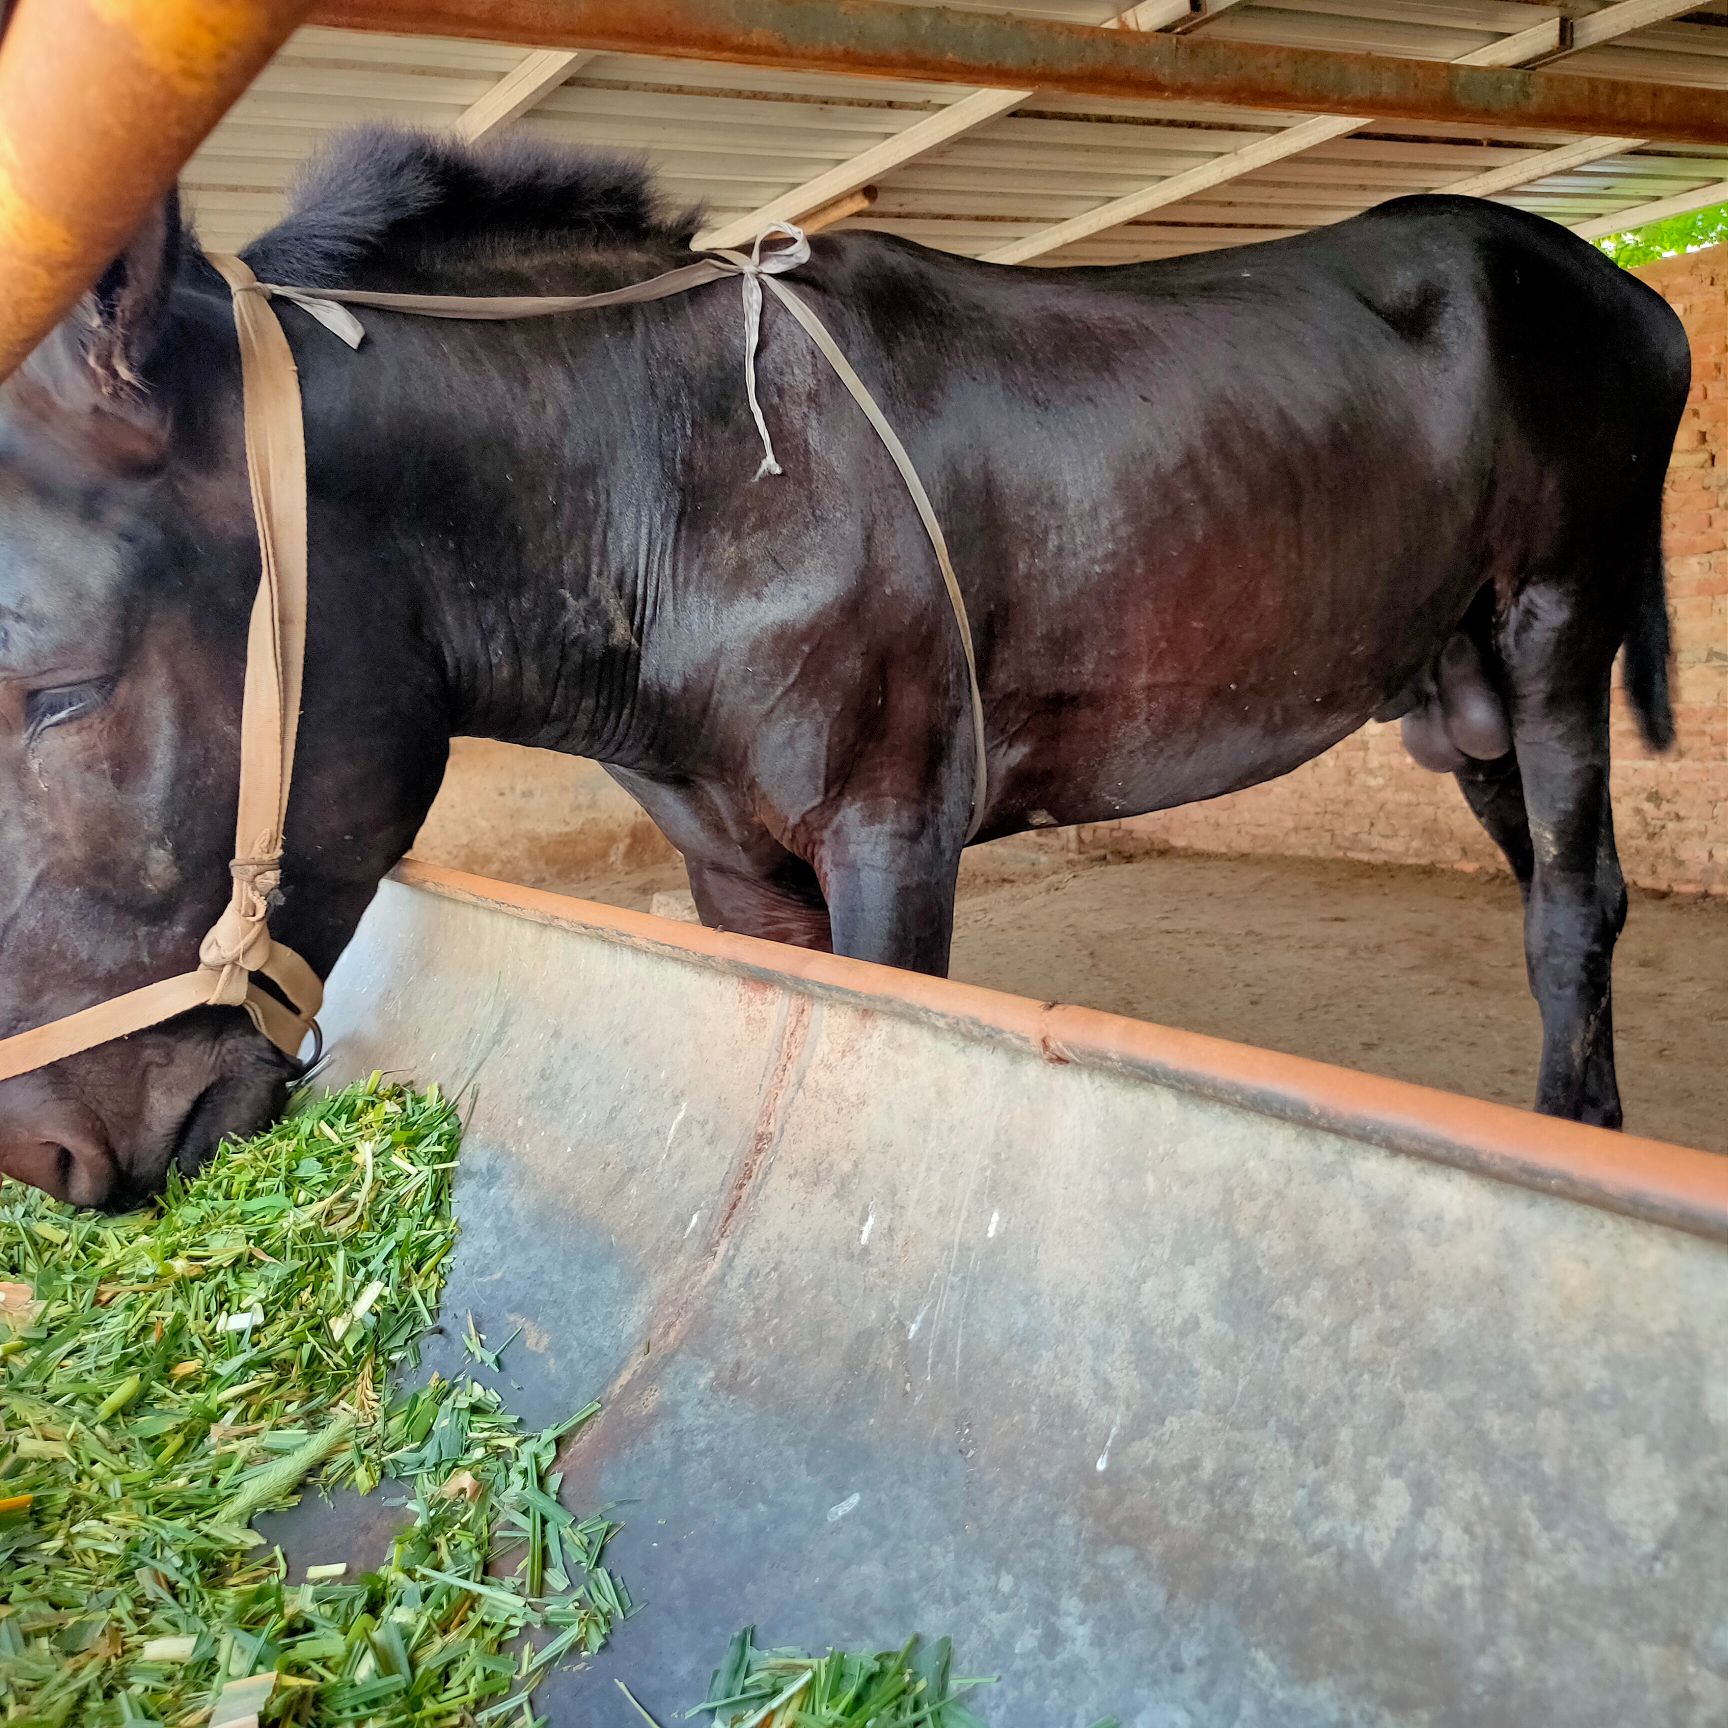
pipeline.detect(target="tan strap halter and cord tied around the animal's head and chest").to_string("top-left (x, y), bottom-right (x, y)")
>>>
top-left (0, 223), bottom-right (988, 1080)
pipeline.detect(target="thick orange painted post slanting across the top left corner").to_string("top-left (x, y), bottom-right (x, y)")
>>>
top-left (0, 0), bottom-right (309, 378)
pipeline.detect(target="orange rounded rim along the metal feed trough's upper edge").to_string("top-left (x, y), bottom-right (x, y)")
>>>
top-left (394, 859), bottom-right (1728, 1246)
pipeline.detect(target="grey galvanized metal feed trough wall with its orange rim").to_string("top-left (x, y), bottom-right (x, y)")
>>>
top-left (279, 869), bottom-right (1728, 1728)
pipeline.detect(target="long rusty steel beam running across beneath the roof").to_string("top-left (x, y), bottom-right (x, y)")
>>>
top-left (313, 0), bottom-right (1728, 143)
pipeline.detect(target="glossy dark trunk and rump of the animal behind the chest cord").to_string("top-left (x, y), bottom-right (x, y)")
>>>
top-left (801, 197), bottom-right (1688, 821)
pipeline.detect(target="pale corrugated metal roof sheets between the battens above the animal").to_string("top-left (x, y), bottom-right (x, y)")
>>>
top-left (185, 0), bottom-right (1728, 263)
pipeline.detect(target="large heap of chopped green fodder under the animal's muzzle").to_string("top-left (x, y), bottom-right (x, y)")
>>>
top-left (0, 1075), bottom-right (629, 1728)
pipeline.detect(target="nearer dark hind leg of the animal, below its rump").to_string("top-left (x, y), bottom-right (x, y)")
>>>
top-left (1496, 586), bottom-right (1626, 1128)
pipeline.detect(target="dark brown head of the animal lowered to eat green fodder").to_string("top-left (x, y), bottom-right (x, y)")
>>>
top-left (0, 200), bottom-right (446, 1206)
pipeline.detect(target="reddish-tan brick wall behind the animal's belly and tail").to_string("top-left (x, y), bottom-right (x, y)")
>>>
top-left (1077, 247), bottom-right (1728, 893)
